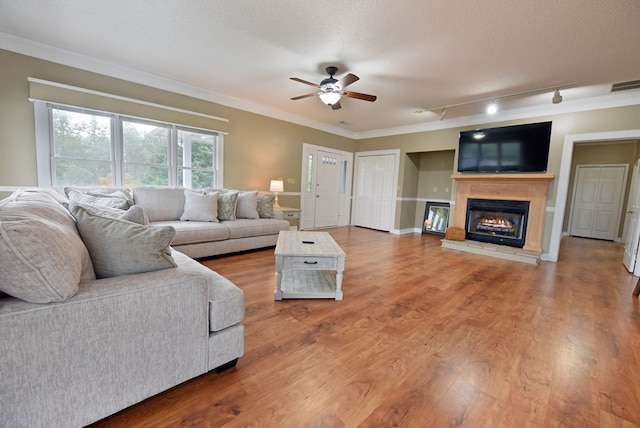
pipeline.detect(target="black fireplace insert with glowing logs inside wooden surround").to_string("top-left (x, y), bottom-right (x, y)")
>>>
top-left (465, 198), bottom-right (529, 248)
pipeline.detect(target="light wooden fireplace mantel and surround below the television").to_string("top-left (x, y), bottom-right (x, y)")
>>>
top-left (451, 174), bottom-right (554, 252)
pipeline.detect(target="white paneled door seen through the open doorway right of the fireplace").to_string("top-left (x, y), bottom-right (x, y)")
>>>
top-left (569, 165), bottom-right (626, 241)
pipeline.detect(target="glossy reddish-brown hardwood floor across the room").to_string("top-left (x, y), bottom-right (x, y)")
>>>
top-left (89, 227), bottom-right (640, 428)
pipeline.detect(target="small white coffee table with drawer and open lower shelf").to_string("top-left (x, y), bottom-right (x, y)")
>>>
top-left (274, 230), bottom-right (346, 300)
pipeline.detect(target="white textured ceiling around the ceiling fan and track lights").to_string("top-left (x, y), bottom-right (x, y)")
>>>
top-left (0, 0), bottom-right (640, 136)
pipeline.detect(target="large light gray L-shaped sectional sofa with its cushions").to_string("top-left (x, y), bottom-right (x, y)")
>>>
top-left (0, 187), bottom-right (288, 427)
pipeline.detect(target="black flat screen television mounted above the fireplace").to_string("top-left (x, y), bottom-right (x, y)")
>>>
top-left (458, 122), bottom-right (551, 173)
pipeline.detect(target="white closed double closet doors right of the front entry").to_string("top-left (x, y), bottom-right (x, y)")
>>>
top-left (353, 150), bottom-right (397, 231)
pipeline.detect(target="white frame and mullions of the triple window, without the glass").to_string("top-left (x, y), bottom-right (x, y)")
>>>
top-left (33, 100), bottom-right (224, 188)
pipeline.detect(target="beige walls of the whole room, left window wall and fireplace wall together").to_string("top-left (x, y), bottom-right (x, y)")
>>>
top-left (0, 50), bottom-right (640, 250)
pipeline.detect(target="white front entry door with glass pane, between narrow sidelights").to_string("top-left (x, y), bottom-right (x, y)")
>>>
top-left (314, 150), bottom-right (342, 227)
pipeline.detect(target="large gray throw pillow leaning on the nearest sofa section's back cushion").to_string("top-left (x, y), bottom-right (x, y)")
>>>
top-left (72, 204), bottom-right (176, 278)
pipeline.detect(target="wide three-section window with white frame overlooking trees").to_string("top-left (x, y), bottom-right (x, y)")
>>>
top-left (36, 102), bottom-right (223, 189)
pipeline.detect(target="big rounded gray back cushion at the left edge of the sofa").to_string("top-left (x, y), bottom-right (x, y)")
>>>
top-left (0, 190), bottom-right (95, 303)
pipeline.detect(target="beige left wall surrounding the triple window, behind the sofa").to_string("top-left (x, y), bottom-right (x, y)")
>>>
top-left (0, 50), bottom-right (355, 207)
